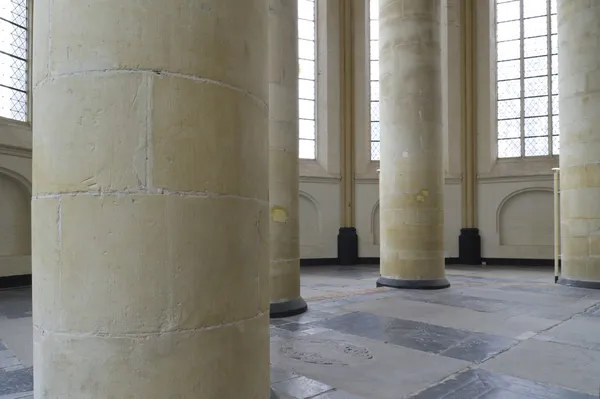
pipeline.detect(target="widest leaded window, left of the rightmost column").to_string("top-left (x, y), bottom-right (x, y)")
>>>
top-left (496, 0), bottom-right (560, 158)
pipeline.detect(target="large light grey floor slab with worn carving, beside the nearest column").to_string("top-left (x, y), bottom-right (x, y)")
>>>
top-left (271, 331), bottom-right (470, 399)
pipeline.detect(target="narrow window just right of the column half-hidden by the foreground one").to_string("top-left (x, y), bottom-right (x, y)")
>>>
top-left (298, 0), bottom-right (317, 159)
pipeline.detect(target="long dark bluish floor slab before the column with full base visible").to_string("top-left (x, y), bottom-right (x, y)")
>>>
top-left (315, 312), bottom-right (516, 362)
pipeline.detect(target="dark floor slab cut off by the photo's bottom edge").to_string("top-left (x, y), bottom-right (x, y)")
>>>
top-left (412, 369), bottom-right (597, 399)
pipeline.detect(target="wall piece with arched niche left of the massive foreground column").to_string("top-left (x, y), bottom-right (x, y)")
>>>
top-left (0, 118), bottom-right (31, 277)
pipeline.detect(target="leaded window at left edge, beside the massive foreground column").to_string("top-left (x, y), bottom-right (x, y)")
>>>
top-left (0, 0), bottom-right (28, 122)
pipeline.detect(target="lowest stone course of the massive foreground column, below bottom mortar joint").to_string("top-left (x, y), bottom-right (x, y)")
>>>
top-left (34, 314), bottom-right (269, 399)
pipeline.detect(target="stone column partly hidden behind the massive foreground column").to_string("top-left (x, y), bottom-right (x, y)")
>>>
top-left (268, 0), bottom-right (307, 317)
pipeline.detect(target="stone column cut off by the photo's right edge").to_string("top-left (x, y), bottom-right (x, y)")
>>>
top-left (558, 0), bottom-right (600, 289)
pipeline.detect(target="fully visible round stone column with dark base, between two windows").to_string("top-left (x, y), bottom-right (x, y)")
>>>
top-left (377, 0), bottom-right (449, 289)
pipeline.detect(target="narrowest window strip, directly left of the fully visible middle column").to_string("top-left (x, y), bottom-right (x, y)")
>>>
top-left (369, 0), bottom-right (380, 161)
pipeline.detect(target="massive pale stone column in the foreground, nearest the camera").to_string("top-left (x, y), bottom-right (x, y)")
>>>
top-left (32, 0), bottom-right (269, 399)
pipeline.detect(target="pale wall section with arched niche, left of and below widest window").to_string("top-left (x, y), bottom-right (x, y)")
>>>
top-left (475, 1), bottom-right (558, 259)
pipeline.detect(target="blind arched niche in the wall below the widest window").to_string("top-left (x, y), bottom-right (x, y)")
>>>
top-left (496, 187), bottom-right (554, 246)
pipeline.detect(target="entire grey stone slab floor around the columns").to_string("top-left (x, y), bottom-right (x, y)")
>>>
top-left (0, 266), bottom-right (600, 399)
